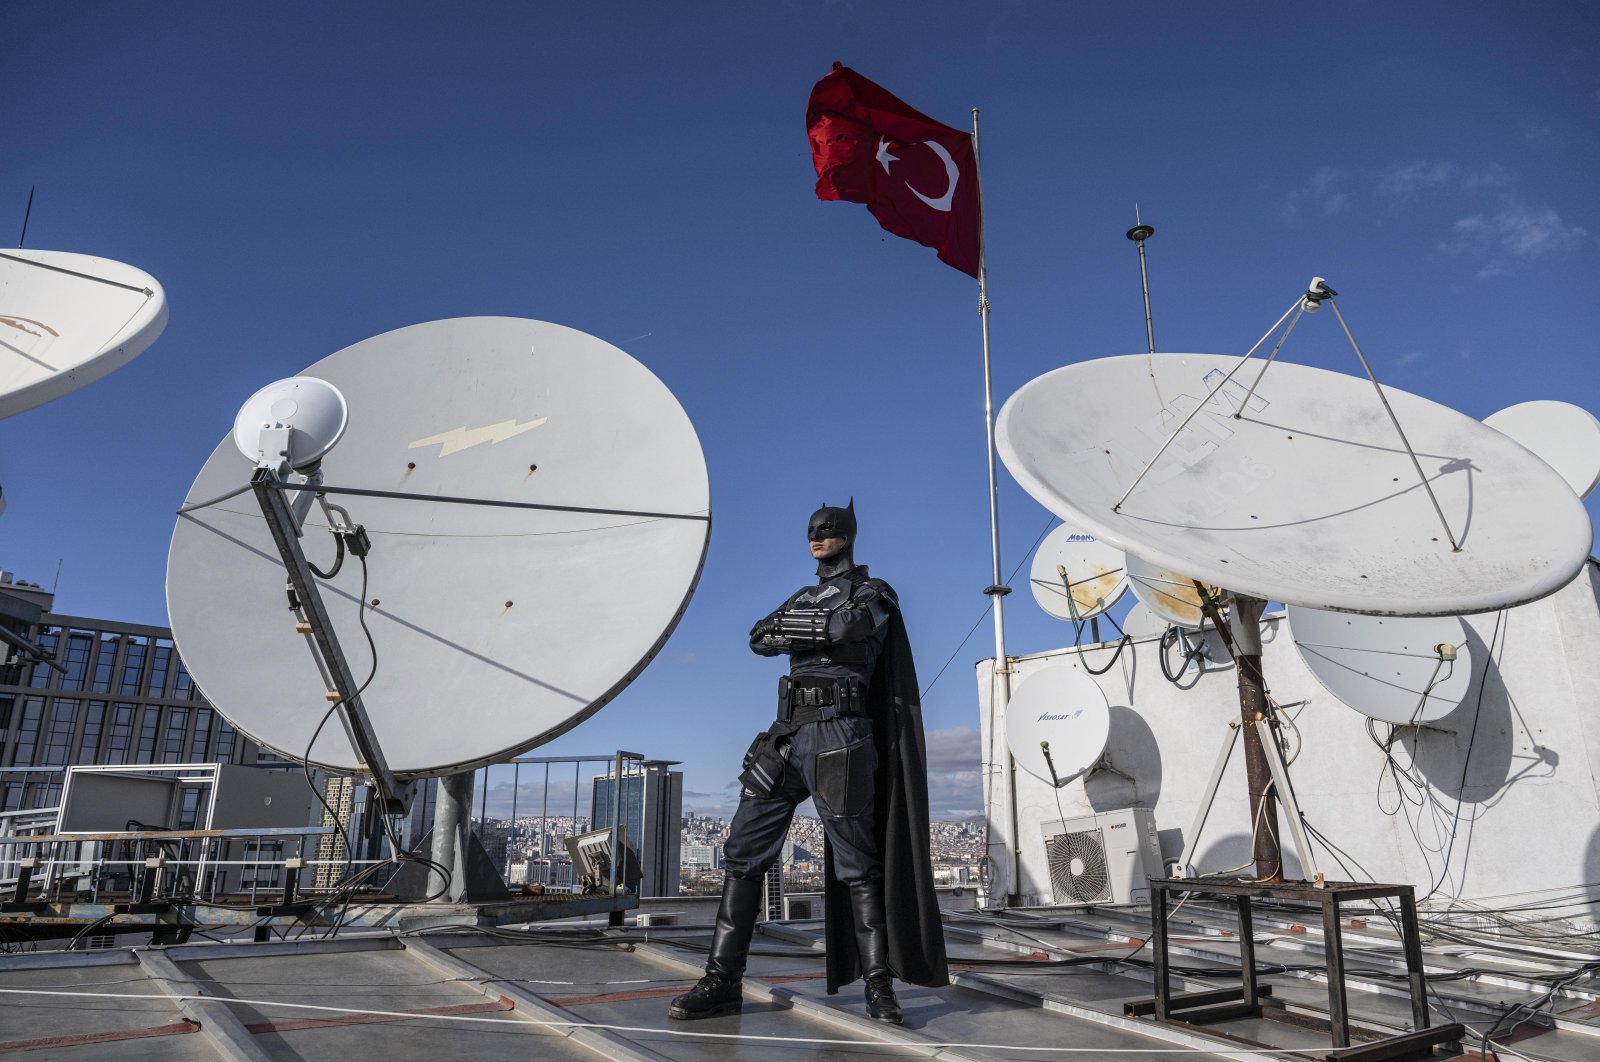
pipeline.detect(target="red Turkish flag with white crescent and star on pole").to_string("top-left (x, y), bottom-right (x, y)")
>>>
top-left (805, 62), bottom-right (982, 277)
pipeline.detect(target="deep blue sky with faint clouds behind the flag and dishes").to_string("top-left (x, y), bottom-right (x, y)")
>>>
top-left (0, 3), bottom-right (1600, 816)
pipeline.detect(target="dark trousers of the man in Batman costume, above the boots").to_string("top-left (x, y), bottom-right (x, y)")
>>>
top-left (723, 715), bottom-right (883, 884)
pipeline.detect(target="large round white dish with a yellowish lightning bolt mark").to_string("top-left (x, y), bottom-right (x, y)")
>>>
top-left (166, 317), bottom-right (710, 777)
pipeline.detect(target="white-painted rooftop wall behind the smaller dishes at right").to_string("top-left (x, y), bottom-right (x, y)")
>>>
top-left (978, 561), bottom-right (1600, 905)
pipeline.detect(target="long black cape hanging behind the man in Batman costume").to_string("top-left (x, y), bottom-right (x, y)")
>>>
top-left (824, 608), bottom-right (950, 995)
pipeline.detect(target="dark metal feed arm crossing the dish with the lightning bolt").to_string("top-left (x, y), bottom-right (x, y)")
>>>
top-left (250, 465), bottom-right (416, 816)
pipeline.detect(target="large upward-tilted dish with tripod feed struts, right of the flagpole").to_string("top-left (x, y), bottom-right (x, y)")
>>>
top-left (995, 353), bottom-right (1590, 616)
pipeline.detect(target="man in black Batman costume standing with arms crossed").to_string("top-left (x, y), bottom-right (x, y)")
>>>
top-left (669, 499), bottom-right (949, 1024)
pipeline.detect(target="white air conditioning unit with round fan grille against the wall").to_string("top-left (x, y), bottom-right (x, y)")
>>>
top-left (1043, 808), bottom-right (1163, 904)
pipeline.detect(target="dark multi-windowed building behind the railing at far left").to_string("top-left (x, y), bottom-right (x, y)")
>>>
top-left (0, 573), bottom-right (260, 812)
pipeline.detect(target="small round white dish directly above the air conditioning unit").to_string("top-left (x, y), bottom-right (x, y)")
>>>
top-left (1005, 664), bottom-right (1110, 787)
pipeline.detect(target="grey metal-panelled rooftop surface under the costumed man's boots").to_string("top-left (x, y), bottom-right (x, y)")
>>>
top-left (0, 900), bottom-right (1600, 1062)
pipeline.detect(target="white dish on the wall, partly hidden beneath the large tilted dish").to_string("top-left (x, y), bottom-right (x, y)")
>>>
top-left (1286, 605), bottom-right (1472, 726)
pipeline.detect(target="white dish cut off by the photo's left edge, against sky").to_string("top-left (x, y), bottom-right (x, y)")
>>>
top-left (0, 248), bottom-right (166, 417)
